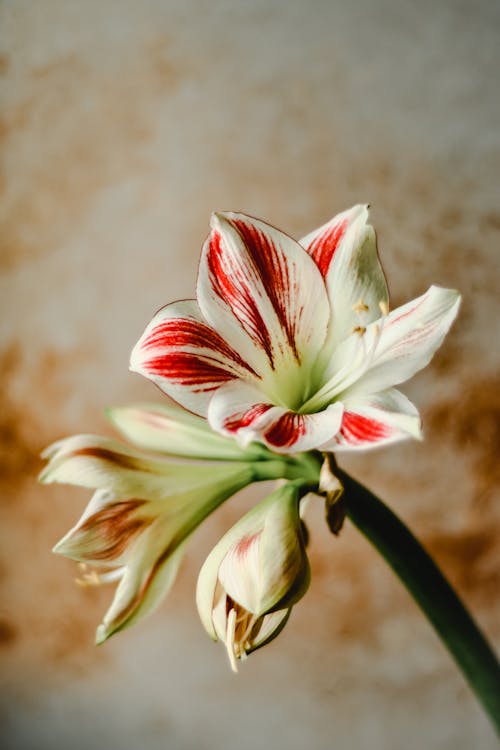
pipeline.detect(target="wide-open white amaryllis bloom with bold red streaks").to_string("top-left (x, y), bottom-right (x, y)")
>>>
top-left (131, 206), bottom-right (460, 453)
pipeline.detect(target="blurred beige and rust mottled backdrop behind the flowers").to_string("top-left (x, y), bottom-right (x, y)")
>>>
top-left (0, 0), bottom-right (500, 750)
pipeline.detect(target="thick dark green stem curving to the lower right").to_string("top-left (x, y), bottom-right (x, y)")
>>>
top-left (335, 469), bottom-right (500, 734)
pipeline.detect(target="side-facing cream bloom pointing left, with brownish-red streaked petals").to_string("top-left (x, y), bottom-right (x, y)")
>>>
top-left (40, 406), bottom-right (296, 642)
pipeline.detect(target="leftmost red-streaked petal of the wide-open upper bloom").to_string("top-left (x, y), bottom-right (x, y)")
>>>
top-left (130, 300), bottom-right (259, 416)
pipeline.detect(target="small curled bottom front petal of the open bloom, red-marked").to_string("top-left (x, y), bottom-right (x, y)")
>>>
top-left (208, 382), bottom-right (343, 453)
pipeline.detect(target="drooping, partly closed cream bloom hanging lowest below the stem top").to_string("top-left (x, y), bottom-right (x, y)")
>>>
top-left (196, 481), bottom-right (309, 671)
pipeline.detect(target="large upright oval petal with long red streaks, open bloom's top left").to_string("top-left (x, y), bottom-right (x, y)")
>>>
top-left (197, 213), bottom-right (329, 374)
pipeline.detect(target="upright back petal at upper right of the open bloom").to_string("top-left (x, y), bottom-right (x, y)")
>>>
top-left (301, 205), bottom-right (389, 348)
